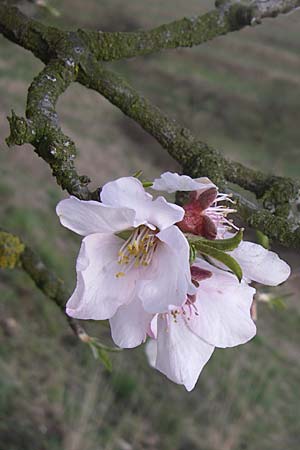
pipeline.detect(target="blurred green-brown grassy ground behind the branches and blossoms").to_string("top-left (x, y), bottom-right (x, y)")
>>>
top-left (0, 0), bottom-right (300, 450)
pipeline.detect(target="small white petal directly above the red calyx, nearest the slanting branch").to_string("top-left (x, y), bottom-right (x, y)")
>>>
top-left (152, 172), bottom-right (216, 194)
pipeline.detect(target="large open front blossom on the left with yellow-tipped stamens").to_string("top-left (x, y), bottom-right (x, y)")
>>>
top-left (57, 177), bottom-right (194, 324)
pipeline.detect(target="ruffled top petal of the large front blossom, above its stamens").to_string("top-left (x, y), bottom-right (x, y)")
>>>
top-left (100, 177), bottom-right (184, 230)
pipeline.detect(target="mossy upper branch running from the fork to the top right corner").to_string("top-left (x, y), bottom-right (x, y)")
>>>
top-left (79, 0), bottom-right (300, 61)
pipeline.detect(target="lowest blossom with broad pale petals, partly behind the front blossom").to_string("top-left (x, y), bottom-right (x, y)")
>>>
top-left (136, 259), bottom-right (256, 391)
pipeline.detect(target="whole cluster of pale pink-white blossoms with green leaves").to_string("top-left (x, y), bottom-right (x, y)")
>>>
top-left (57, 172), bottom-right (290, 390)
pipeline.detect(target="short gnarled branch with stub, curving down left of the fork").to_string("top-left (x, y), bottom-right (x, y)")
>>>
top-left (7, 33), bottom-right (98, 200)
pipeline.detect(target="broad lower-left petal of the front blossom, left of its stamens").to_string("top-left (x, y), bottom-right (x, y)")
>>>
top-left (66, 234), bottom-right (138, 320)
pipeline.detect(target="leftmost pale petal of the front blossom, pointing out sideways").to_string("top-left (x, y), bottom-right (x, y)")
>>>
top-left (56, 197), bottom-right (135, 236)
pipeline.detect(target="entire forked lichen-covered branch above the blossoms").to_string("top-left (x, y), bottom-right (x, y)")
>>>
top-left (0, 0), bottom-right (300, 248)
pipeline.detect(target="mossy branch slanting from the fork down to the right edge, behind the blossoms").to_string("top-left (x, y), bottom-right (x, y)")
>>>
top-left (78, 60), bottom-right (300, 248)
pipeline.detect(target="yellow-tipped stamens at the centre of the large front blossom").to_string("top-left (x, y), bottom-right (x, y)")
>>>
top-left (116, 225), bottom-right (158, 278)
